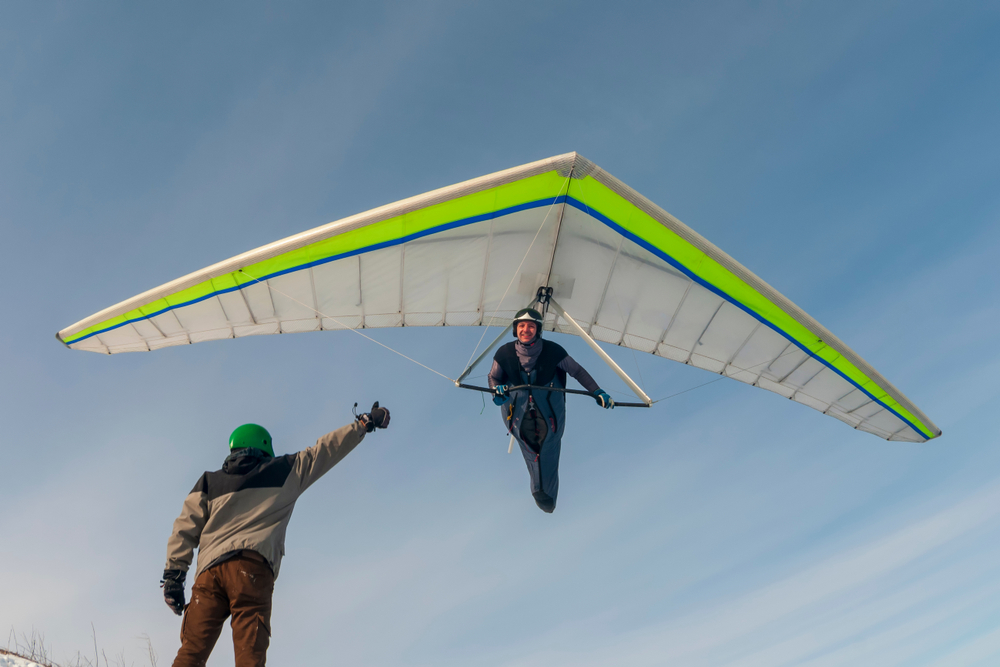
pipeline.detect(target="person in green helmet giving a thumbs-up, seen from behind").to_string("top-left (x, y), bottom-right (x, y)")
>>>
top-left (161, 402), bottom-right (389, 667)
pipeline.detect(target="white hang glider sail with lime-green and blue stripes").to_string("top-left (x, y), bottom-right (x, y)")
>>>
top-left (57, 153), bottom-right (941, 442)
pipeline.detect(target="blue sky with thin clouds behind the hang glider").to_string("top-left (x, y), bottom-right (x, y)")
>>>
top-left (0, 2), bottom-right (1000, 667)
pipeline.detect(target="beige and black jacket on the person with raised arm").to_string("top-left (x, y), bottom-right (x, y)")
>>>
top-left (165, 422), bottom-right (365, 578)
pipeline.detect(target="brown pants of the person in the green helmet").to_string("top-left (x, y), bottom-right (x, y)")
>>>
top-left (173, 554), bottom-right (274, 667)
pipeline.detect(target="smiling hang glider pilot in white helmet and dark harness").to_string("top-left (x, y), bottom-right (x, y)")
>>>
top-left (489, 308), bottom-right (615, 513)
